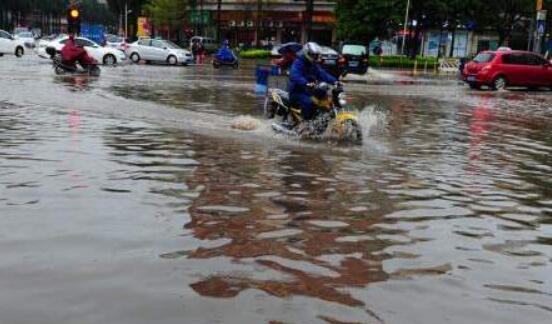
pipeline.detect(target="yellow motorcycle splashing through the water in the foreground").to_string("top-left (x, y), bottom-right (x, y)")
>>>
top-left (264, 83), bottom-right (362, 144)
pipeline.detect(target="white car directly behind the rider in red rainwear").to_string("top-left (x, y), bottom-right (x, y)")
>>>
top-left (36, 36), bottom-right (127, 65)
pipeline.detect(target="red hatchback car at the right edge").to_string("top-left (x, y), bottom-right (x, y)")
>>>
top-left (462, 50), bottom-right (552, 90)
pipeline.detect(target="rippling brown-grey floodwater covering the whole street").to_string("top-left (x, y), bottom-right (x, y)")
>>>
top-left (0, 57), bottom-right (552, 324)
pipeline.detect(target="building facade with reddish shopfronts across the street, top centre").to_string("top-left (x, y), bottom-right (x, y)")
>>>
top-left (187, 0), bottom-right (336, 45)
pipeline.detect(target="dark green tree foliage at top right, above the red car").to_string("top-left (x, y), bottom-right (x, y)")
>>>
top-left (337, 0), bottom-right (552, 43)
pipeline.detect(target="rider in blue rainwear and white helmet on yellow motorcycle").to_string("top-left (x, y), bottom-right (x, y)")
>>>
top-left (288, 42), bottom-right (338, 120)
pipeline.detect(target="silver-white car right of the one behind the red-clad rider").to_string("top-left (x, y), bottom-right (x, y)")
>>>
top-left (127, 39), bottom-right (194, 65)
